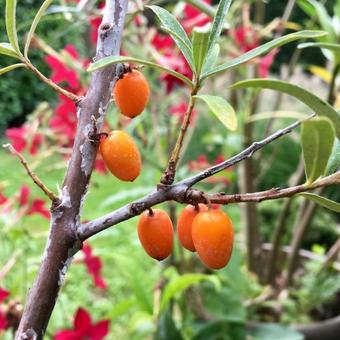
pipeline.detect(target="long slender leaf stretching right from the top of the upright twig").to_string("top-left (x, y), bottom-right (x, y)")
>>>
top-left (202, 31), bottom-right (327, 78)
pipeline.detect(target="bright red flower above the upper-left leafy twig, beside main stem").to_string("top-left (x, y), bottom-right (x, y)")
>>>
top-left (45, 44), bottom-right (80, 90)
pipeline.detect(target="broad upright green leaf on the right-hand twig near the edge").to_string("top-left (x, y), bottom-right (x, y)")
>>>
top-left (301, 117), bottom-right (335, 184)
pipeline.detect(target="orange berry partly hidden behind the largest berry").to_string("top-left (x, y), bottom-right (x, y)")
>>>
top-left (177, 204), bottom-right (208, 252)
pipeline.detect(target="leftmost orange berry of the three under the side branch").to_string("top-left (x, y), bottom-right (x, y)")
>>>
top-left (137, 209), bottom-right (174, 261)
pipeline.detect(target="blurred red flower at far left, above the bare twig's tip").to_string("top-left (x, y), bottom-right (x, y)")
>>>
top-left (5, 125), bottom-right (43, 155)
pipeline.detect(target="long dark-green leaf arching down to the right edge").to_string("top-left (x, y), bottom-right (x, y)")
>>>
top-left (231, 79), bottom-right (340, 139)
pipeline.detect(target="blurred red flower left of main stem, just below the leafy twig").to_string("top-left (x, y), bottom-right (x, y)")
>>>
top-left (50, 95), bottom-right (77, 145)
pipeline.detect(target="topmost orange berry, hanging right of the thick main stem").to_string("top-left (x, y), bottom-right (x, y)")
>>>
top-left (113, 70), bottom-right (150, 118)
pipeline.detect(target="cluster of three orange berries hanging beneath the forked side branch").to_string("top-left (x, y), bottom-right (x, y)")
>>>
top-left (138, 204), bottom-right (234, 269)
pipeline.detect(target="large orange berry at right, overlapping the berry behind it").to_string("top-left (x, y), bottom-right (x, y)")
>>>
top-left (192, 210), bottom-right (234, 269)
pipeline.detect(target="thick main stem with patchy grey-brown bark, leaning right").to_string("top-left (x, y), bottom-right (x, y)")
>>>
top-left (15, 0), bottom-right (128, 340)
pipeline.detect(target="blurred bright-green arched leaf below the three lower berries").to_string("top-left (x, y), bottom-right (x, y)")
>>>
top-left (160, 273), bottom-right (219, 311)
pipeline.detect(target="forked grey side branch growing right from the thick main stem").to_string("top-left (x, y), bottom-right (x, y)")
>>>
top-left (78, 121), bottom-right (318, 241)
